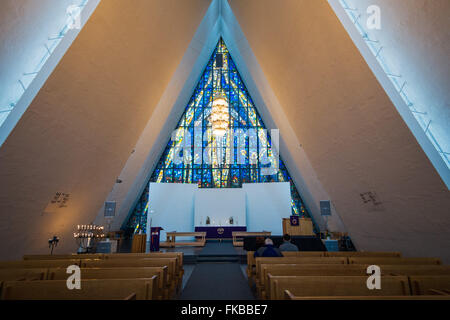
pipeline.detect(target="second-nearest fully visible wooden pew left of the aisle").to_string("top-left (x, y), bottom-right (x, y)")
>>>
top-left (47, 266), bottom-right (170, 300)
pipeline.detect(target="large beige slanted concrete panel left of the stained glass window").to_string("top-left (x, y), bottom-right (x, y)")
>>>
top-left (0, 0), bottom-right (210, 259)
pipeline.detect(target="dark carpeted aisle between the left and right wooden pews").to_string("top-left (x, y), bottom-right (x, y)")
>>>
top-left (180, 263), bottom-right (255, 300)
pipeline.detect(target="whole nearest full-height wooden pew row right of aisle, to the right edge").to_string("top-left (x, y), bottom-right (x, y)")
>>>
top-left (268, 274), bottom-right (450, 300)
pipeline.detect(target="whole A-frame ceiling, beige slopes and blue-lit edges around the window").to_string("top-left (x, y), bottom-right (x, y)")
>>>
top-left (0, 0), bottom-right (450, 259)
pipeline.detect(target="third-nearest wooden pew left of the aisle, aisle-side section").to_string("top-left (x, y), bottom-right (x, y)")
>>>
top-left (81, 258), bottom-right (182, 296)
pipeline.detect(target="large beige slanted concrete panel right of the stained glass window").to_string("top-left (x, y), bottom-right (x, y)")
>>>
top-left (229, 0), bottom-right (450, 259)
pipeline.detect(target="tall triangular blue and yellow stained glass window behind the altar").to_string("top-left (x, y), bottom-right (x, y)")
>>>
top-left (124, 39), bottom-right (317, 233)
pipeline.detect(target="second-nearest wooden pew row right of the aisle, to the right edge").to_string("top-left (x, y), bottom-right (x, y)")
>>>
top-left (255, 264), bottom-right (450, 299)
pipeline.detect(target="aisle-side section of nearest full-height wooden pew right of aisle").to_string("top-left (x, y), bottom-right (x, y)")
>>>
top-left (268, 273), bottom-right (410, 300)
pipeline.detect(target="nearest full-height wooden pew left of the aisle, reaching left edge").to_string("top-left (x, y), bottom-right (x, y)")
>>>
top-left (1, 276), bottom-right (158, 300)
